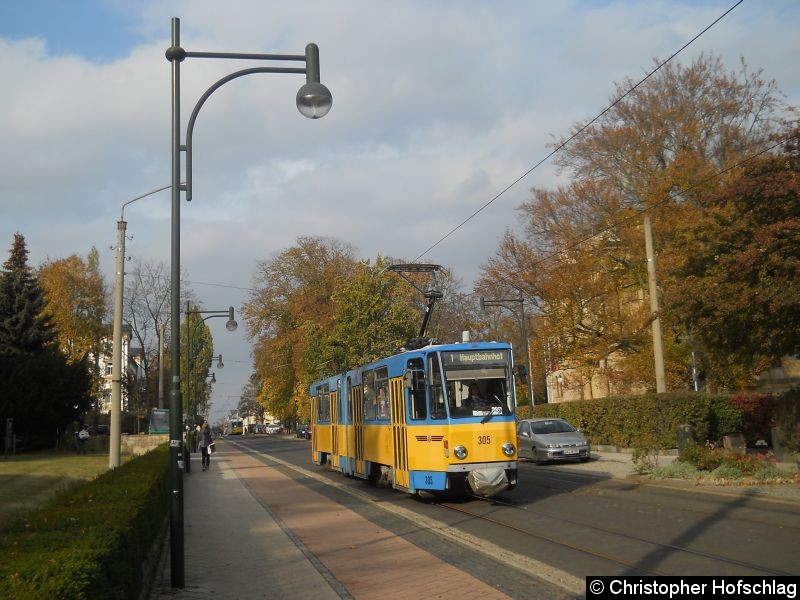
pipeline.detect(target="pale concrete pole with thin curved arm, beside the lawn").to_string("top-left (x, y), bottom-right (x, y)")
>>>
top-left (108, 185), bottom-right (172, 469)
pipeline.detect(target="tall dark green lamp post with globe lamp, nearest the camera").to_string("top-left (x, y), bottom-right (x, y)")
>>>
top-left (166, 17), bottom-right (332, 588)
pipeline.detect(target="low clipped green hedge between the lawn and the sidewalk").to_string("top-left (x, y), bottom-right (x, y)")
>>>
top-left (0, 444), bottom-right (168, 600)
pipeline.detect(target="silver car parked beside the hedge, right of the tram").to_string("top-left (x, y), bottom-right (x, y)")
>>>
top-left (517, 419), bottom-right (592, 463)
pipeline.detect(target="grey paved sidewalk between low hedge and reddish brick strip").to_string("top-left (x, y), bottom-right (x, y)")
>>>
top-left (150, 440), bottom-right (348, 600)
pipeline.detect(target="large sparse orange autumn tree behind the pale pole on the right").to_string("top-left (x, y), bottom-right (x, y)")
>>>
top-left (481, 56), bottom-right (783, 392)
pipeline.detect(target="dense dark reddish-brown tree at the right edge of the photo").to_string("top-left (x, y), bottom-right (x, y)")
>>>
top-left (672, 128), bottom-right (800, 385)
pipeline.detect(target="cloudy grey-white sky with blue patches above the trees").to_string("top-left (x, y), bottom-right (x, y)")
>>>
top-left (0, 0), bottom-right (800, 420)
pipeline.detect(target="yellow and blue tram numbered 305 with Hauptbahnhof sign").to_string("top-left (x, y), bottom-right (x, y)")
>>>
top-left (310, 342), bottom-right (517, 496)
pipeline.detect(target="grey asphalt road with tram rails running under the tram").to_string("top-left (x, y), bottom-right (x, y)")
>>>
top-left (225, 436), bottom-right (800, 596)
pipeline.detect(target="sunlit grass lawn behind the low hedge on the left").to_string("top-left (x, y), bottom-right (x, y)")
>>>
top-left (0, 452), bottom-right (131, 527)
